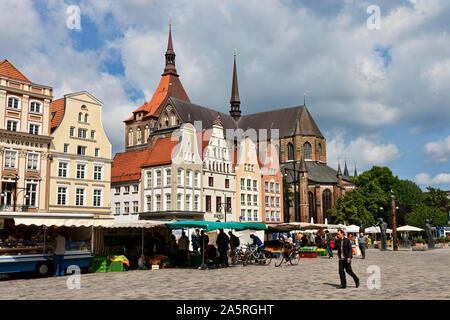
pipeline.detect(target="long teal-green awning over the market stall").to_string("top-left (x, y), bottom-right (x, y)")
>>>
top-left (166, 220), bottom-right (267, 232)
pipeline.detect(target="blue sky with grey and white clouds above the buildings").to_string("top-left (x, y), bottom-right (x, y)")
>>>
top-left (0, 0), bottom-right (450, 190)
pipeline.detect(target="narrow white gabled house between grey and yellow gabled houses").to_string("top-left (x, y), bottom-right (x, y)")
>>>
top-left (200, 116), bottom-right (236, 221)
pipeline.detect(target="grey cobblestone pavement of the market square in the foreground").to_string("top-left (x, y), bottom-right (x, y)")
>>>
top-left (0, 248), bottom-right (450, 300)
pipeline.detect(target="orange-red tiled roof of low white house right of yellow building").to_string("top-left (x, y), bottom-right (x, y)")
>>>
top-left (111, 149), bottom-right (151, 183)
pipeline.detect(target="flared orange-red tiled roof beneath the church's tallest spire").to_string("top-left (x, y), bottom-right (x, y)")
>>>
top-left (125, 74), bottom-right (190, 122)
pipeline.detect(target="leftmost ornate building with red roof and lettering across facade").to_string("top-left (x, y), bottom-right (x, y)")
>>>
top-left (0, 60), bottom-right (53, 212)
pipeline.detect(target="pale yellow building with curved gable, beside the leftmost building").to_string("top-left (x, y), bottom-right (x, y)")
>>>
top-left (49, 92), bottom-right (112, 217)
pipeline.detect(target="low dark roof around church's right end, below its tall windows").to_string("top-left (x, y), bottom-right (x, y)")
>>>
top-left (281, 161), bottom-right (351, 184)
